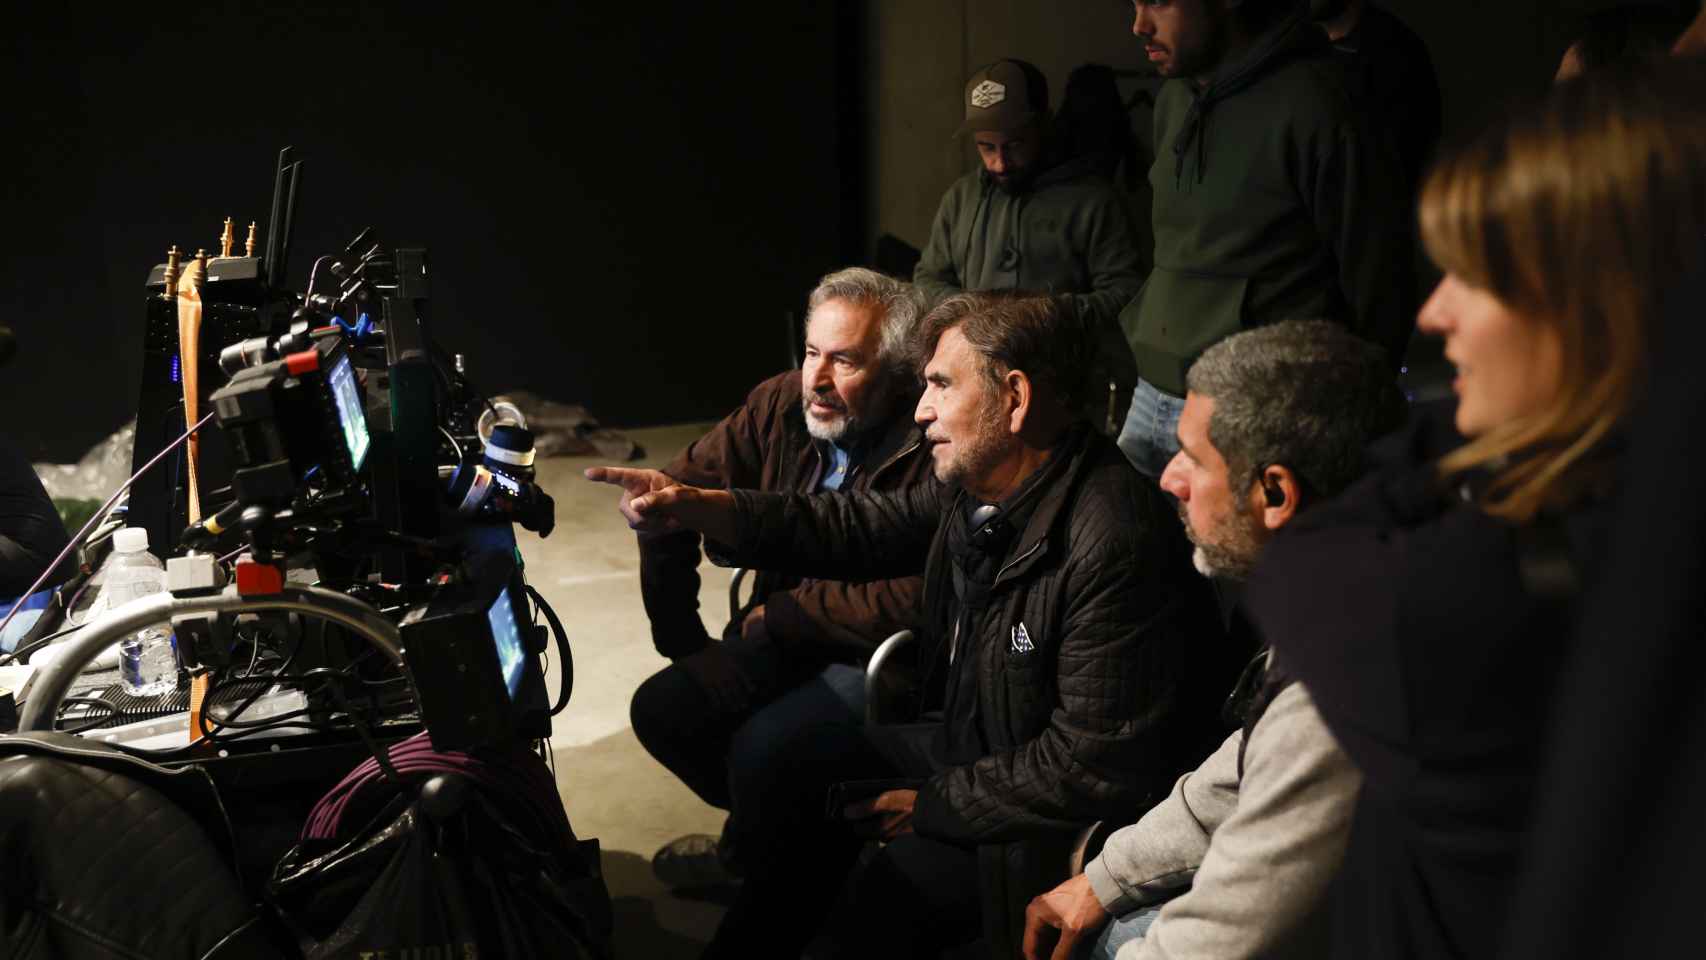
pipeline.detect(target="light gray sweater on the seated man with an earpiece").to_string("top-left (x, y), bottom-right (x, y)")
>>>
top-left (1085, 684), bottom-right (1361, 960)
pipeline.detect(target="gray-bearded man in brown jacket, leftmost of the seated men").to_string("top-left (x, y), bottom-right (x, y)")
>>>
top-left (630, 268), bottom-right (930, 887)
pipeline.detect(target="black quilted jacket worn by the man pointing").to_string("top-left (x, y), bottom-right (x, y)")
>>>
top-left (713, 430), bottom-right (1237, 957)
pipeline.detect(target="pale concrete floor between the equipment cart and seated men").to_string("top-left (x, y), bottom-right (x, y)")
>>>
top-left (515, 423), bottom-right (732, 960)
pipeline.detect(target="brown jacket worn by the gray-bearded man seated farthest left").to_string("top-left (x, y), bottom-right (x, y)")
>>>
top-left (640, 370), bottom-right (937, 662)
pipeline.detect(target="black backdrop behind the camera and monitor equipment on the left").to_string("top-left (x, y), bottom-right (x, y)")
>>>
top-left (0, 2), bottom-right (860, 460)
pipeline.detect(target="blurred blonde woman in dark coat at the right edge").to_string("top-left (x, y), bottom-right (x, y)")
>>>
top-left (1247, 63), bottom-right (1706, 958)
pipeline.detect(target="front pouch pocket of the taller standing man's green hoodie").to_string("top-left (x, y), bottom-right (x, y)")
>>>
top-left (1121, 266), bottom-right (1250, 396)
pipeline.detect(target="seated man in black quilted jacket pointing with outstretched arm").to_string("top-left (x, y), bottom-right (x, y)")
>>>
top-left (587, 293), bottom-right (1242, 957)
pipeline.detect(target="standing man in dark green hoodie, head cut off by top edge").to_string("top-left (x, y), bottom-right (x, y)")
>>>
top-left (1119, 0), bottom-right (1416, 477)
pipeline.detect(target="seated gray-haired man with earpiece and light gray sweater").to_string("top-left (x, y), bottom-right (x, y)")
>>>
top-left (1024, 321), bottom-right (1404, 960)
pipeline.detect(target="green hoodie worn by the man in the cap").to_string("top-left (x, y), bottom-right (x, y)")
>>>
top-left (913, 153), bottom-right (1143, 387)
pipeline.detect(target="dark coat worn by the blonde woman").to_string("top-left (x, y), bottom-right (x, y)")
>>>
top-left (1245, 411), bottom-right (1607, 958)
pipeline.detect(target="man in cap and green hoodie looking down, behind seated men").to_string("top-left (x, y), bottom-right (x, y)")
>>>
top-left (913, 60), bottom-right (1143, 428)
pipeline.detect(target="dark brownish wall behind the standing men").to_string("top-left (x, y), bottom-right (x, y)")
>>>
top-left (862, 0), bottom-right (1671, 255)
